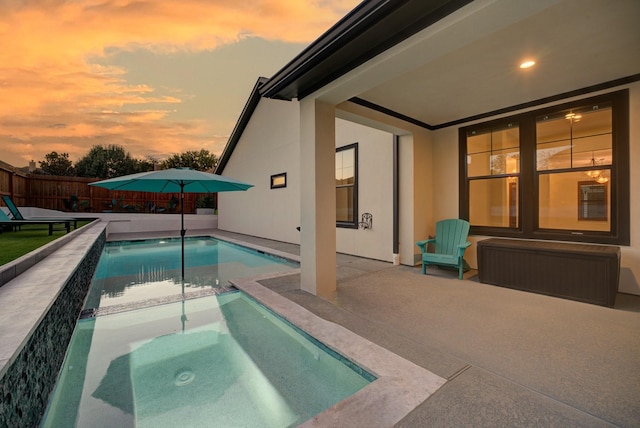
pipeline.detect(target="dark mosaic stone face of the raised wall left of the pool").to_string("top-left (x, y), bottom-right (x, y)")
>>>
top-left (0, 228), bottom-right (106, 427)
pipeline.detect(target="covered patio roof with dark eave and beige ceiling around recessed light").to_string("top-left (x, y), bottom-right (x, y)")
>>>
top-left (260, 0), bottom-right (640, 129)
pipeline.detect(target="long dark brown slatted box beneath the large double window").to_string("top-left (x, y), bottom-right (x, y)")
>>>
top-left (478, 238), bottom-right (620, 307)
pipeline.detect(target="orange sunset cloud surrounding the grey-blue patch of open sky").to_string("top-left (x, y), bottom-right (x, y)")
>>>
top-left (0, 0), bottom-right (358, 166)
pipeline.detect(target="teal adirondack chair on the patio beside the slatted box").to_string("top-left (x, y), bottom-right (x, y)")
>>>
top-left (416, 218), bottom-right (471, 279)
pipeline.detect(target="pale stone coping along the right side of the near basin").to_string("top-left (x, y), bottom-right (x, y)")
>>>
top-left (230, 272), bottom-right (446, 427)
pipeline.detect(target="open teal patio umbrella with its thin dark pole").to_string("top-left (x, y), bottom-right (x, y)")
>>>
top-left (89, 168), bottom-right (253, 283)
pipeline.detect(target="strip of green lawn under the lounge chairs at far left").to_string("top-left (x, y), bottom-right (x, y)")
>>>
top-left (0, 221), bottom-right (90, 265)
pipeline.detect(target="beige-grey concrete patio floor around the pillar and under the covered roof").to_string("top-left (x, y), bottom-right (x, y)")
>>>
top-left (215, 230), bottom-right (640, 427)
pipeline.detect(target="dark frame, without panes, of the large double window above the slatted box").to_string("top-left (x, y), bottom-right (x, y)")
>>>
top-left (458, 89), bottom-right (630, 245)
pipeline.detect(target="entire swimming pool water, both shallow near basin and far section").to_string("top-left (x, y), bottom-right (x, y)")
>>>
top-left (43, 238), bottom-right (374, 427)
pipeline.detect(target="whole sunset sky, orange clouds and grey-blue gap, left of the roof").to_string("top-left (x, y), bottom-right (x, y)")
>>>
top-left (0, 0), bottom-right (359, 167)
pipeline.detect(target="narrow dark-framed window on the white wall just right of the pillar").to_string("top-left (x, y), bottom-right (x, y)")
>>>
top-left (336, 143), bottom-right (358, 229)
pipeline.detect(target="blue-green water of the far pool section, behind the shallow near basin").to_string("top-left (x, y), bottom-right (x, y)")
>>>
top-left (84, 237), bottom-right (299, 309)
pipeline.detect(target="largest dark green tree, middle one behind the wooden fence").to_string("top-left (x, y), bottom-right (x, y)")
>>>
top-left (76, 144), bottom-right (148, 178)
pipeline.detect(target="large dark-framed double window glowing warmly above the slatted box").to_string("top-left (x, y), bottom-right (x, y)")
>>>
top-left (460, 91), bottom-right (629, 245)
